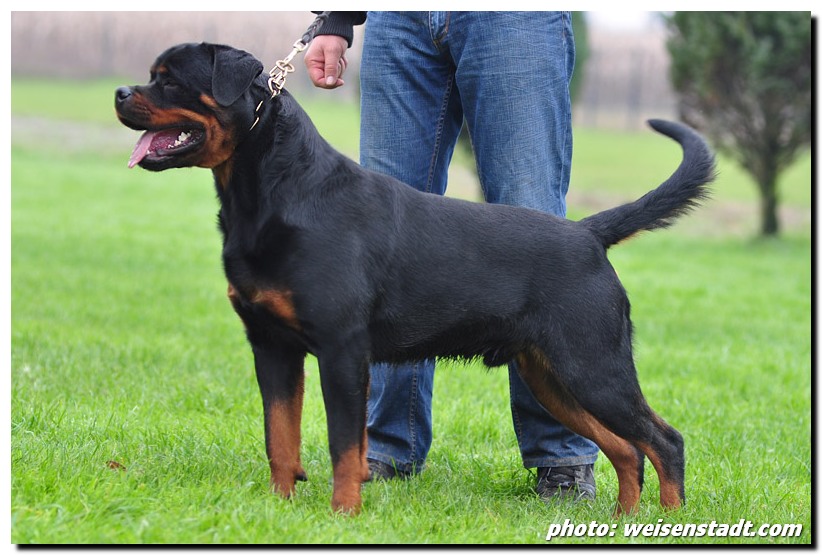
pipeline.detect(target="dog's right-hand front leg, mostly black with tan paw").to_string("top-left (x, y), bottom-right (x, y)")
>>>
top-left (319, 343), bottom-right (369, 514)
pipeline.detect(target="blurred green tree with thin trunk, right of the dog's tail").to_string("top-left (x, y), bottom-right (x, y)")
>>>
top-left (666, 12), bottom-right (813, 235)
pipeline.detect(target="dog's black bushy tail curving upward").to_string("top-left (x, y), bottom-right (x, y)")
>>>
top-left (580, 119), bottom-right (715, 249)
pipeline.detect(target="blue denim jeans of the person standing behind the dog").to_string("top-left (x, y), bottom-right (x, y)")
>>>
top-left (360, 12), bottom-right (598, 472)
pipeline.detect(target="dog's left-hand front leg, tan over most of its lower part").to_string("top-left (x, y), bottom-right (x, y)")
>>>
top-left (252, 343), bottom-right (306, 498)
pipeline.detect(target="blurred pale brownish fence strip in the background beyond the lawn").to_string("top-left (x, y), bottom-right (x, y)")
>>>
top-left (11, 11), bottom-right (675, 128)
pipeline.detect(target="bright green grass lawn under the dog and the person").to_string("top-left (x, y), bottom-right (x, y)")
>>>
top-left (11, 82), bottom-right (813, 545)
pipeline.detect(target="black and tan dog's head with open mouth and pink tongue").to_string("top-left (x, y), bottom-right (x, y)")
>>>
top-left (114, 43), bottom-right (263, 171)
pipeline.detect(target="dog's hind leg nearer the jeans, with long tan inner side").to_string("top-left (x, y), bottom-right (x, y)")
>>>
top-left (516, 349), bottom-right (645, 514)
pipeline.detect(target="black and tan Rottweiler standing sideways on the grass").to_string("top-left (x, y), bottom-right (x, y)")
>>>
top-left (115, 44), bottom-right (713, 512)
